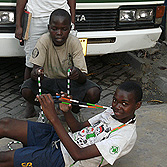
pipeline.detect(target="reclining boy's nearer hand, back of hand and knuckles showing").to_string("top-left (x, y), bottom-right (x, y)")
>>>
top-left (37, 94), bottom-right (57, 121)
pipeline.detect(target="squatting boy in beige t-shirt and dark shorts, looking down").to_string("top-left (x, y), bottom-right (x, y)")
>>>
top-left (21, 9), bottom-right (101, 116)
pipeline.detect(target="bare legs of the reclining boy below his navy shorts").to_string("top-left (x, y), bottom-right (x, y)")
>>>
top-left (0, 118), bottom-right (28, 167)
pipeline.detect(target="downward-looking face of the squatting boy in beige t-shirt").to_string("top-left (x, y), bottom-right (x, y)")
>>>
top-left (48, 16), bottom-right (71, 46)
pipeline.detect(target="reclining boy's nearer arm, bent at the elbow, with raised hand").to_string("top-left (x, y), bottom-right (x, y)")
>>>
top-left (37, 94), bottom-right (101, 161)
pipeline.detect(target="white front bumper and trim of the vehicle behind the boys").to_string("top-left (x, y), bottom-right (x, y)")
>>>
top-left (0, 1), bottom-right (163, 57)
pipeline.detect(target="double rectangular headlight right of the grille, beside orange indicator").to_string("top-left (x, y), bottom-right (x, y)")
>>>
top-left (119, 9), bottom-right (153, 22)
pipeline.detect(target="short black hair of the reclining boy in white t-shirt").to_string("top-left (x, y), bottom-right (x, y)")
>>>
top-left (117, 81), bottom-right (143, 103)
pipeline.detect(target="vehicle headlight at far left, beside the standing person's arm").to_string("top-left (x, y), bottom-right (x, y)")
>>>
top-left (0, 11), bottom-right (14, 24)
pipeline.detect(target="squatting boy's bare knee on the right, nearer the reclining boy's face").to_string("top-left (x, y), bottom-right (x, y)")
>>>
top-left (85, 87), bottom-right (101, 103)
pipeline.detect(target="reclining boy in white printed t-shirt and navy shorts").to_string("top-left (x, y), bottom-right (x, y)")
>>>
top-left (0, 81), bottom-right (142, 167)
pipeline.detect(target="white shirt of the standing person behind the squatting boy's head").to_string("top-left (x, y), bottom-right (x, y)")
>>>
top-left (26, 0), bottom-right (70, 17)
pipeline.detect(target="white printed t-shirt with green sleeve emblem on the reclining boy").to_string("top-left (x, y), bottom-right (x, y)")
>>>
top-left (61, 109), bottom-right (137, 167)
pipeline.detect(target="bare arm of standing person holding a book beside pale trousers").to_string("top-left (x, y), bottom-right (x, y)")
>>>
top-left (15, 0), bottom-right (28, 40)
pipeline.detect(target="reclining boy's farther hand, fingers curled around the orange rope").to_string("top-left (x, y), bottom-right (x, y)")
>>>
top-left (59, 92), bottom-right (72, 112)
